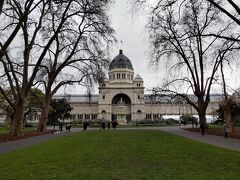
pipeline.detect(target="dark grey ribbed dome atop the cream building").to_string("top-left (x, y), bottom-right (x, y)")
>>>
top-left (109, 50), bottom-right (133, 70)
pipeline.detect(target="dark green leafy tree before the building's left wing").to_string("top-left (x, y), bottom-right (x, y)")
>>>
top-left (48, 98), bottom-right (72, 124)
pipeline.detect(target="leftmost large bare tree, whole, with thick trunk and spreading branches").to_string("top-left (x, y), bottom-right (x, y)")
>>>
top-left (0, 0), bottom-right (113, 135)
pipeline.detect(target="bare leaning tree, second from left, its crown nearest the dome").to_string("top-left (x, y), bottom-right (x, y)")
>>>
top-left (35, 1), bottom-right (114, 131)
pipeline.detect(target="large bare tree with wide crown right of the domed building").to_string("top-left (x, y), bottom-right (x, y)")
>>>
top-left (144, 0), bottom-right (238, 125)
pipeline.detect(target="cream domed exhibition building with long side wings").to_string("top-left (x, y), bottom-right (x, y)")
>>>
top-left (54, 50), bottom-right (222, 124)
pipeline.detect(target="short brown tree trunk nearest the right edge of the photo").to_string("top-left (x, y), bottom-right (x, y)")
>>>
top-left (224, 100), bottom-right (234, 133)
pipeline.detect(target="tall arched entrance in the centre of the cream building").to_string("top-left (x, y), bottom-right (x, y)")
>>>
top-left (112, 94), bottom-right (131, 124)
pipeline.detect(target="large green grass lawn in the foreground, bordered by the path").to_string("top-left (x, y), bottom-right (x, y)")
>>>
top-left (0, 130), bottom-right (240, 180)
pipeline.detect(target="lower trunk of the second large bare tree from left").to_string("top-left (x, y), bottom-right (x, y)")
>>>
top-left (38, 95), bottom-right (51, 132)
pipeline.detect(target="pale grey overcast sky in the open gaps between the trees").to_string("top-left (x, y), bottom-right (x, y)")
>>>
top-left (59, 0), bottom-right (240, 94)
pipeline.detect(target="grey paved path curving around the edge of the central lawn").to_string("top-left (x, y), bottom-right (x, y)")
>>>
top-left (0, 126), bottom-right (240, 154)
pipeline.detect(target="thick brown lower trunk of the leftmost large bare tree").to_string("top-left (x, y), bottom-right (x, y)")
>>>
top-left (11, 98), bottom-right (26, 136)
